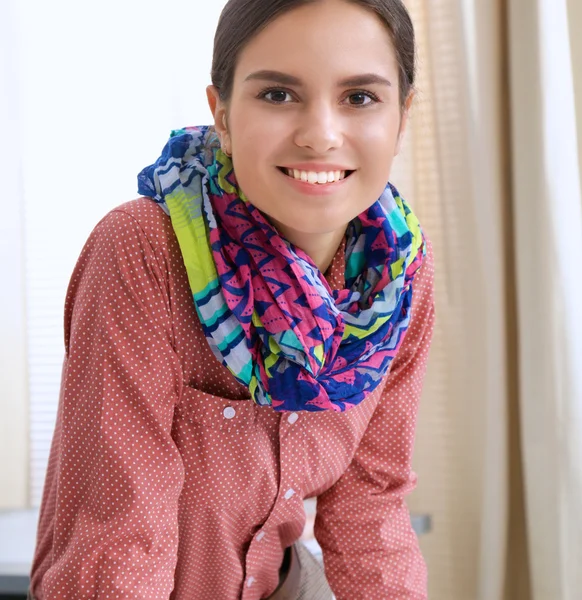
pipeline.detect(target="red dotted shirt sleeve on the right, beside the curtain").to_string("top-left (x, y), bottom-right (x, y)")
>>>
top-left (314, 242), bottom-right (434, 600)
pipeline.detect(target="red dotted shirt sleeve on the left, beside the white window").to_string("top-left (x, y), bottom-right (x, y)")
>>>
top-left (31, 210), bottom-right (184, 600)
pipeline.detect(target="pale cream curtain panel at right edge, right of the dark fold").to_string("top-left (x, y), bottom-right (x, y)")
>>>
top-left (509, 0), bottom-right (582, 600)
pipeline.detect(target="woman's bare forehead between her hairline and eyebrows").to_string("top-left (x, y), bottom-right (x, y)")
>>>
top-left (235, 0), bottom-right (398, 80)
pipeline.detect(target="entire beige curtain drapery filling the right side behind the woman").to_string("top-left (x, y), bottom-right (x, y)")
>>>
top-left (394, 0), bottom-right (582, 600)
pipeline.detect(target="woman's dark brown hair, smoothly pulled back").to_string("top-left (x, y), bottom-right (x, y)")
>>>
top-left (212, 0), bottom-right (416, 107)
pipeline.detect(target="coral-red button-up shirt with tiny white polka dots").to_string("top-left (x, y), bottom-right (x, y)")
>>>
top-left (31, 198), bottom-right (434, 600)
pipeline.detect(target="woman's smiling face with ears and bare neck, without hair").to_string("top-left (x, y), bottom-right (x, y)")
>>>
top-left (208, 0), bottom-right (411, 260)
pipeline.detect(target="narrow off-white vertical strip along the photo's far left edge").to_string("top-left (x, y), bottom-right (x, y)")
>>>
top-left (0, 0), bottom-right (28, 511)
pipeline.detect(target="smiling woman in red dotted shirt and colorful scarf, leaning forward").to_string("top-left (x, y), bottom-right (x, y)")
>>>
top-left (30, 0), bottom-right (434, 600)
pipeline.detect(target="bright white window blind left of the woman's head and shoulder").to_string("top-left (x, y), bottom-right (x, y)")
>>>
top-left (18, 0), bottom-right (225, 505)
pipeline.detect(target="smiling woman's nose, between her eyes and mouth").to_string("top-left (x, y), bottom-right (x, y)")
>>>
top-left (295, 100), bottom-right (343, 154)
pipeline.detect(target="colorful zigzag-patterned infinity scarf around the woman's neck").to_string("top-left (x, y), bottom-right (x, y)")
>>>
top-left (138, 127), bottom-right (426, 412)
